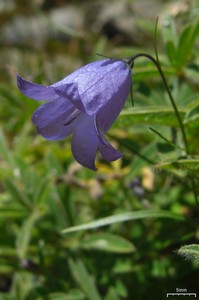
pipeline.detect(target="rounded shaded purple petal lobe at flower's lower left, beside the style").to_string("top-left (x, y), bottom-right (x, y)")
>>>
top-left (32, 98), bottom-right (79, 140)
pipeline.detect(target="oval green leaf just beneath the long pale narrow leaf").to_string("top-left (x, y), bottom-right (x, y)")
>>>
top-left (81, 232), bottom-right (135, 253)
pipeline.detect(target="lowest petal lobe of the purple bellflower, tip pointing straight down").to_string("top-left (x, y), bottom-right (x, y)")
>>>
top-left (71, 115), bottom-right (99, 171)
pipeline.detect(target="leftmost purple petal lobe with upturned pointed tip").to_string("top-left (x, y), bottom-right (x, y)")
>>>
top-left (17, 74), bottom-right (58, 100)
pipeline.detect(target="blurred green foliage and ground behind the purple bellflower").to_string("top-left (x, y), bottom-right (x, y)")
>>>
top-left (0, 0), bottom-right (199, 300)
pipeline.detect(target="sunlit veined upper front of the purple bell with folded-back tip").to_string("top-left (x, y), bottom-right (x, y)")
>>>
top-left (53, 59), bottom-right (131, 115)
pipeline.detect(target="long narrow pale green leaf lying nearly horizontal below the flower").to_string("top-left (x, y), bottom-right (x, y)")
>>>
top-left (62, 210), bottom-right (184, 234)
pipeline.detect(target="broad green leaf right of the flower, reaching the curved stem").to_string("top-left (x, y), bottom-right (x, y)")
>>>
top-left (115, 107), bottom-right (186, 129)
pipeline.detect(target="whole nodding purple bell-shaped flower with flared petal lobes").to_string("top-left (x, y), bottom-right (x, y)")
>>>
top-left (17, 59), bottom-right (132, 170)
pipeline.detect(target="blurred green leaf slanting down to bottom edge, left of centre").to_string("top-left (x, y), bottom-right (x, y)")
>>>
top-left (69, 259), bottom-right (101, 300)
